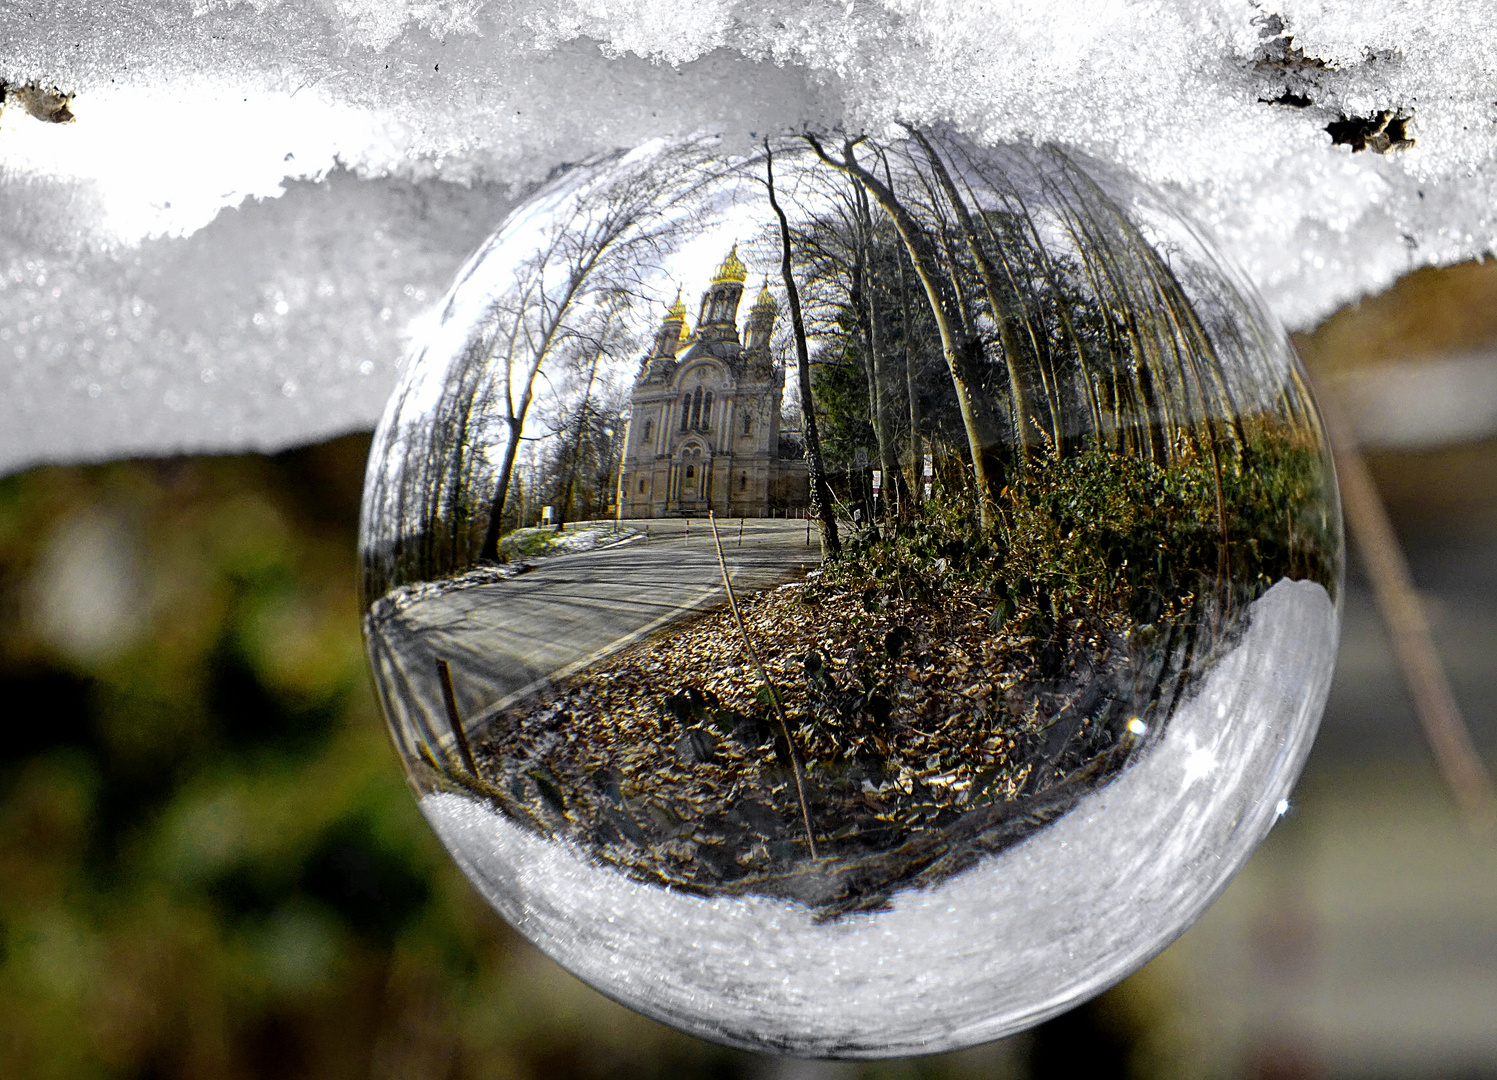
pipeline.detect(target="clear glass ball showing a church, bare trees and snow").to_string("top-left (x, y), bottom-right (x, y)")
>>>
top-left (362, 129), bottom-right (1341, 1056)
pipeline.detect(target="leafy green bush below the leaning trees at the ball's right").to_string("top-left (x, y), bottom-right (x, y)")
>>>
top-left (832, 424), bottom-right (1340, 622)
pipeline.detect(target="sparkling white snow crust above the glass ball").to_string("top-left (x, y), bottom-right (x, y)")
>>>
top-left (0, 0), bottom-right (1497, 469)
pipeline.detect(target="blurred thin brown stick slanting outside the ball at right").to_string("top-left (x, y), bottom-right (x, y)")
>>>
top-left (1316, 374), bottom-right (1497, 833)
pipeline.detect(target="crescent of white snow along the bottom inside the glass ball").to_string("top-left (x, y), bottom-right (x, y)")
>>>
top-left (421, 581), bottom-right (1338, 1058)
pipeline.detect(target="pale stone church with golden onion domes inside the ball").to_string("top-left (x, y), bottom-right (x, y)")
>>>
top-left (620, 247), bottom-right (807, 518)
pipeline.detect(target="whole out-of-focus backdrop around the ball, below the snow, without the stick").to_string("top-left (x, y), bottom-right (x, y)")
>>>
top-left (0, 262), bottom-right (1497, 1080)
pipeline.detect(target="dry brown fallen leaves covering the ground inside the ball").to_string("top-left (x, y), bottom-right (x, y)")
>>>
top-left (458, 572), bottom-right (1215, 917)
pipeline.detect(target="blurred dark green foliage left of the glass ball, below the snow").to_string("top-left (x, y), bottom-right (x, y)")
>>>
top-left (0, 436), bottom-right (1143, 1080)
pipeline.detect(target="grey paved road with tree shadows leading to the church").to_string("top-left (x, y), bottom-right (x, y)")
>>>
top-left (368, 518), bottom-right (820, 763)
